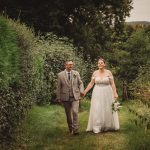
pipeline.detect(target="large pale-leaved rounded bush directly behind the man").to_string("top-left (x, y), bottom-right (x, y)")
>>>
top-left (37, 33), bottom-right (87, 104)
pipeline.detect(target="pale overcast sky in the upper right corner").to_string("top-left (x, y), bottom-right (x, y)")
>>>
top-left (126, 0), bottom-right (150, 21)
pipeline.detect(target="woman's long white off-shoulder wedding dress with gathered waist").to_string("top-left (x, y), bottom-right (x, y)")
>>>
top-left (86, 76), bottom-right (119, 133)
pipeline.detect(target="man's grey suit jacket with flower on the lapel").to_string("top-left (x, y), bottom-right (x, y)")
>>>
top-left (56, 70), bottom-right (84, 101)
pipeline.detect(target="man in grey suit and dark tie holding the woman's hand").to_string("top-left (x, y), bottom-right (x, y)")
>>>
top-left (56, 60), bottom-right (84, 135)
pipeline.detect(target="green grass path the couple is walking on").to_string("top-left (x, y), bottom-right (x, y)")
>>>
top-left (19, 101), bottom-right (150, 150)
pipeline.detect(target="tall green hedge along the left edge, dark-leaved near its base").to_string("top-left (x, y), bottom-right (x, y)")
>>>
top-left (0, 17), bottom-right (40, 143)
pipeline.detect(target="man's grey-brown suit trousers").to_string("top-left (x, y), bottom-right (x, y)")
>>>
top-left (63, 100), bottom-right (79, 132)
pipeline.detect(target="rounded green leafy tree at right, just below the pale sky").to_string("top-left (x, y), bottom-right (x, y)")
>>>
top-left (114, 28), bottom-right (150, 99)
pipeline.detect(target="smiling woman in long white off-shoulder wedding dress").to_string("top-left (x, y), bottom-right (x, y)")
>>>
top-left (84, 58), bottom-right (119, 133)
